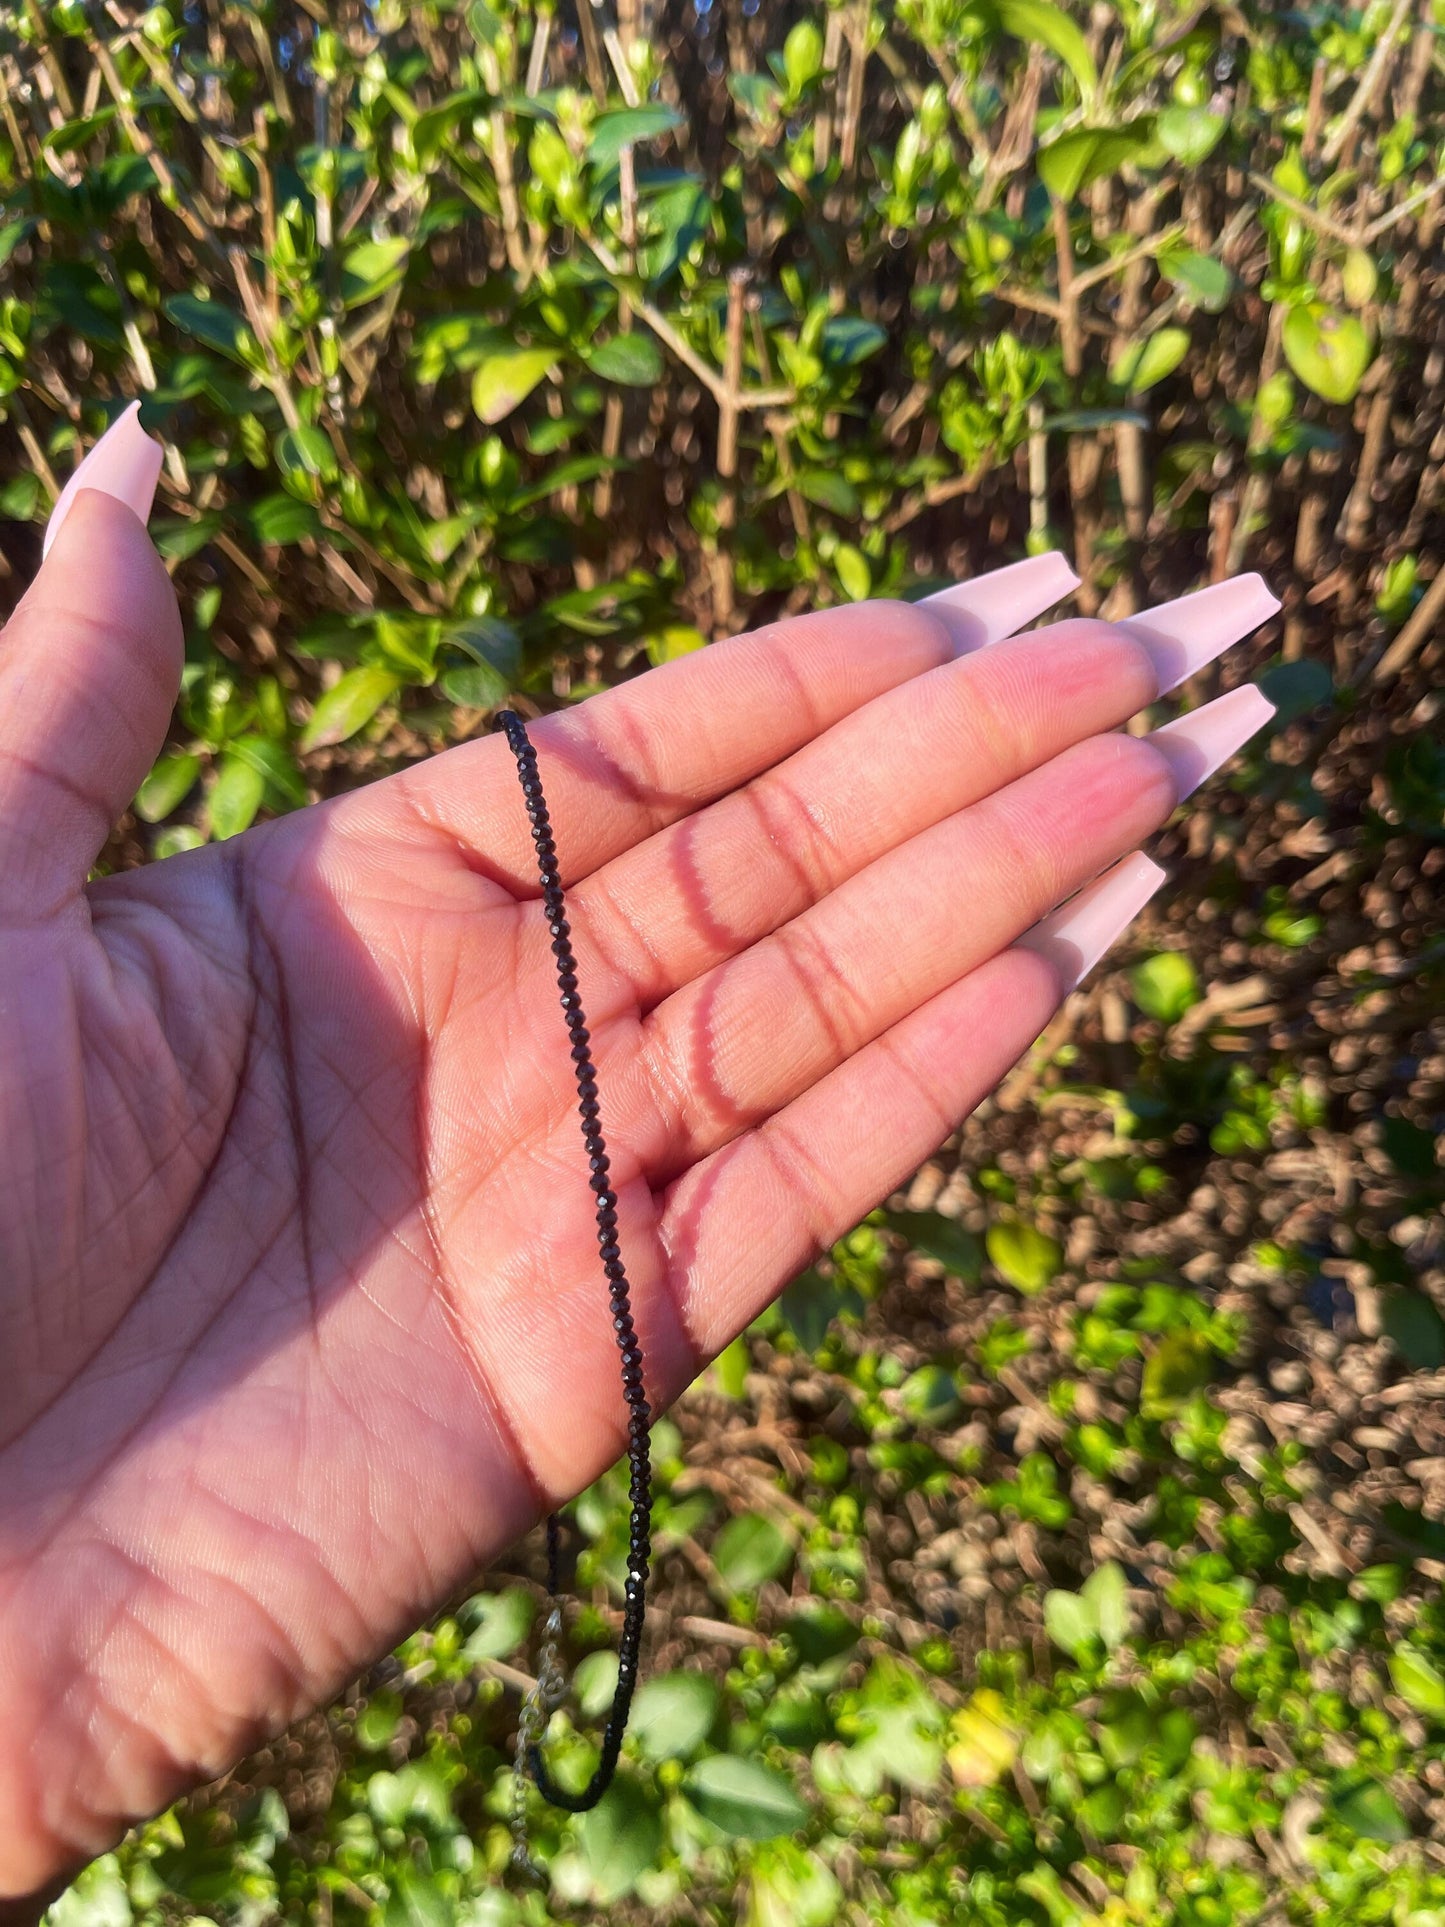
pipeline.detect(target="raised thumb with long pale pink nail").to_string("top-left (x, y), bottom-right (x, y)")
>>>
top-left (0, 403), bottom-right (183, 921)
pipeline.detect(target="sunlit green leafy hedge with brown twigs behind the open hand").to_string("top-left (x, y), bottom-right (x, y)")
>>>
top-left (0, 0), bottom-right (1445, 1927)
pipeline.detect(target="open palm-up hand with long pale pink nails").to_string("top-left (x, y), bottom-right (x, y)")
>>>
top-left (0, 420), bottom-right (1275, 1894)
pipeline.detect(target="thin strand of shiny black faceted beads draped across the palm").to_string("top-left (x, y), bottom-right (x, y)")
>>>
top-left (497, 709), bottom-right (653, 1813)
